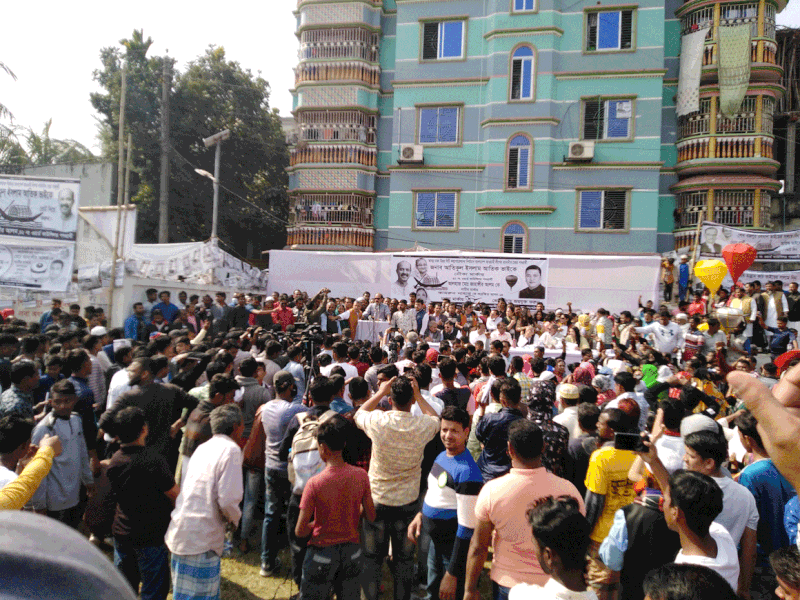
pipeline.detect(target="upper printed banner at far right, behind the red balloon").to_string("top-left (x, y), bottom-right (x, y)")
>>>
top-left (700, 221), bottom-right (800, 262)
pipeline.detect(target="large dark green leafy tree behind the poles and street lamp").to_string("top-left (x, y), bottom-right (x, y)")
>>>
top-left (91, 31), bottom-right (289, 255)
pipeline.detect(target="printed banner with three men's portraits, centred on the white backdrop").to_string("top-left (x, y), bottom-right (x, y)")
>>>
top-left (390, 254), bottom-right (548, 306)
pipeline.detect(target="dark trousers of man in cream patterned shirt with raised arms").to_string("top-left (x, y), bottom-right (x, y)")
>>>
top-left (361, 501), bottom-right (419, 600)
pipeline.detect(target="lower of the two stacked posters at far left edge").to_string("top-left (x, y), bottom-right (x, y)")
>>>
top-left (0, 243), bottom-right (75, 292)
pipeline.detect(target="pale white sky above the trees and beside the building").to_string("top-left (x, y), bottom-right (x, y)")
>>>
top-left (0, 0), bottom-right (800, 152)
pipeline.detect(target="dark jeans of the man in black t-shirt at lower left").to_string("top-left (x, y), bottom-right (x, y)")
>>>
top-left (114, 538), bottom-right (170, 600)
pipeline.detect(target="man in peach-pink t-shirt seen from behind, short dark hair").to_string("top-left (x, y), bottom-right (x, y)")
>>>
top-left (464, 419), bottom-right (585, 600)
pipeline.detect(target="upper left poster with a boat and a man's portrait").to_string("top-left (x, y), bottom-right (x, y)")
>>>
top-left (0, 175), bottom-right (80, 242)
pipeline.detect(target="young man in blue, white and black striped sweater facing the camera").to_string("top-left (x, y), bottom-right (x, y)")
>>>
top-left (408, 406), bottom-right (483, 600)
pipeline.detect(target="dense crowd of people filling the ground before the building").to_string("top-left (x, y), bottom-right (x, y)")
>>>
top-left (0, 282), bottom-right (800, 600)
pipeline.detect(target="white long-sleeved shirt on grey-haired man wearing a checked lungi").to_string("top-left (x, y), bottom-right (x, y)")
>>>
top-left (164, 434), bottom-right (243, 556)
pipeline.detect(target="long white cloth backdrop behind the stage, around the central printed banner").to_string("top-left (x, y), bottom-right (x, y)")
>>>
top-left (268, 250), bottom-right (661, 312)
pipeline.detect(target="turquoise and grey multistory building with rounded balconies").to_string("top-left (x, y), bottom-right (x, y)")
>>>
top-left (288, 0), bottom-right (782, 253)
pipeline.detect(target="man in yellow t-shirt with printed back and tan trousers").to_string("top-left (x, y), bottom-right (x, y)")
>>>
top-left (584, 408), bottom-right (637, 600)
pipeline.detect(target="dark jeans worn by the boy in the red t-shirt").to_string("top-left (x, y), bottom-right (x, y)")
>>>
top-left (300, 544), bottom-right (363, 600)
